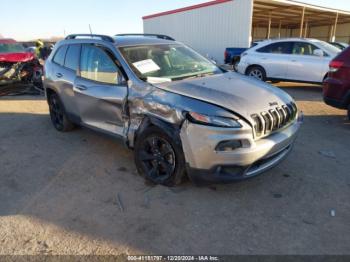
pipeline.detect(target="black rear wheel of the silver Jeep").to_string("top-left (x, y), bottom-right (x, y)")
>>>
top-left (48, 93), bottom-right (74, 132)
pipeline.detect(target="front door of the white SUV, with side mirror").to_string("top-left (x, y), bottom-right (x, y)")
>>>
top-left (286, 42), bottom-right (329, 82)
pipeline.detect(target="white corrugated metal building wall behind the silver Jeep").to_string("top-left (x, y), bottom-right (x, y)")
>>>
top-left (143, 0), bottom-right (253, 63)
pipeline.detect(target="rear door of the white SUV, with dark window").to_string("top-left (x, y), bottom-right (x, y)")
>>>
top-left (254, 42), bottom-right (291, 79)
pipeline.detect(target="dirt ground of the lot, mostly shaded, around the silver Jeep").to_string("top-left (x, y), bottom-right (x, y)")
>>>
top-left (0, 83), bottom-right (350, 254)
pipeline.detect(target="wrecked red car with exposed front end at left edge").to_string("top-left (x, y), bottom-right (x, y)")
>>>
top-left (0, 39), bottom-right (42, 96)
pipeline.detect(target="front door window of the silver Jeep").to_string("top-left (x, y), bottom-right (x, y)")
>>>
top-left (80, 45), bottom-right (122, 84)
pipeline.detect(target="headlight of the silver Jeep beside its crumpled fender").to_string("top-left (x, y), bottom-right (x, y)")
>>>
top-left (188, 112), bottom-right (242, 128)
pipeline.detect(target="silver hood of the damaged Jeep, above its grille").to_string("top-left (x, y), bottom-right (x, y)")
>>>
top-left (155, 72), bottom-right (293, 121)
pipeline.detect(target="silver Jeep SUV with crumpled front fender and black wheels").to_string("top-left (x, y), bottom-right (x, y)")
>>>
top-left (44, 35), bottom-right (300, 186)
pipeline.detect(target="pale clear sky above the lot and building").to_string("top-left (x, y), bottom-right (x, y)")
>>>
top-left (0, 0), bottom-right (350, 41)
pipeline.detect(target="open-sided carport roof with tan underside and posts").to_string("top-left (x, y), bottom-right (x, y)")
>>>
top-left (253, 0), bottom-right (350, 41)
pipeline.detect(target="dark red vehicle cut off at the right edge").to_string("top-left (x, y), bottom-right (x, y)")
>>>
top-left (323, 47), bottom-right (350, 120)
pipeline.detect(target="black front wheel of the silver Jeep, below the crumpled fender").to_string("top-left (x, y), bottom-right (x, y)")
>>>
top-left (134, 126), bottom-right (185, 187)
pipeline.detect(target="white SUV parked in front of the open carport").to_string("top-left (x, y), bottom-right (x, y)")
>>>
top-left (237, 38), bottom-right (340, 83)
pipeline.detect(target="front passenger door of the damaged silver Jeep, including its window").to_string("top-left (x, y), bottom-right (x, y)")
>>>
top-left (74, 44), bottom-right (128, 136)
